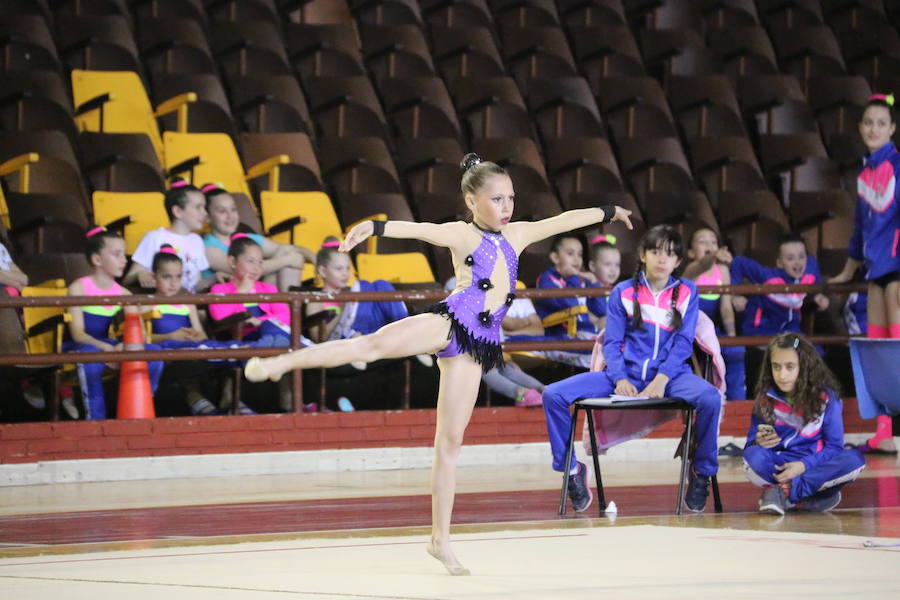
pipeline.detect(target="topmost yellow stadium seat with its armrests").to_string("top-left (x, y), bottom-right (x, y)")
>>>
top-left (72, 69), bottom-right (197, 164)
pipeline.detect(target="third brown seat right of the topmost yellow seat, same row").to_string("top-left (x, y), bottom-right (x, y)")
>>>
top-left (306, 77), bottom-right (389, 140)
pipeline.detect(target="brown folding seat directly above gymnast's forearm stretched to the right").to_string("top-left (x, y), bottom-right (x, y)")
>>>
top-left (547, 137), bottom-right (625, 210)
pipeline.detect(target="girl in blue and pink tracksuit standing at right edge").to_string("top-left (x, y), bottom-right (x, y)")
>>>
top-left (829, 94), bottom-right (900, 454)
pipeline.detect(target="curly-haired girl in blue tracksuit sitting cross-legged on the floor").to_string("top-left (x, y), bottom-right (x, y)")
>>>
top-left (744, 333), bottom-right (865, 515)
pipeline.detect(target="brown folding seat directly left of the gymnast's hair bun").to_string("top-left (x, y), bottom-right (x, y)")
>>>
top-left (397, 138), bottom-right (465, 195)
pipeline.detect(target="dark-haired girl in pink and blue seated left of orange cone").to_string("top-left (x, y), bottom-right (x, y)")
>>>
top-left (63, 227), bottom-right (163, 420)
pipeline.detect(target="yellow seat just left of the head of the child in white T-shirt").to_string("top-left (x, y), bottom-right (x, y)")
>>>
top-left (93, 192), bottom-right (169, 254)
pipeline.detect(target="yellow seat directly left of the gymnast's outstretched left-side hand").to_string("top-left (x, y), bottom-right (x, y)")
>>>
top-left (260, 192), bottom-right (341, 279)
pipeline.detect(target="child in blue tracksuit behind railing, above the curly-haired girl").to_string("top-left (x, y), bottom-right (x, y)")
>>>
top-left (731, 234), bottom-right (828, 335)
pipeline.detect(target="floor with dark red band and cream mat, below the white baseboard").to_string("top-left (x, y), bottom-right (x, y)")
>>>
top-left (0, 450), bottom-right (900, 600)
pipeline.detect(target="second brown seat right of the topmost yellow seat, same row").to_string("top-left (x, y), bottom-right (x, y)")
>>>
top-left (228, 75), bottom-right (314, 135)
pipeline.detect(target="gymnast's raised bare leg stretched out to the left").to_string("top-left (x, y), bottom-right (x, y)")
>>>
top-left (244, 313), bottom-right (450, 381)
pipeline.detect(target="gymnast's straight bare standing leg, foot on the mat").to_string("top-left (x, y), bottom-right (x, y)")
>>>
top-left (427, 354), bottom-right (481, 575)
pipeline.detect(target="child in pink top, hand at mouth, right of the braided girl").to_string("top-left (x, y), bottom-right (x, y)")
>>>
top-left (684, 227), bottom-right (747, 400)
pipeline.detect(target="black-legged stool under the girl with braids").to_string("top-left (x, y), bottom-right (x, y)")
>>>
top-left (559, 398), bottom-right (722, 517)
